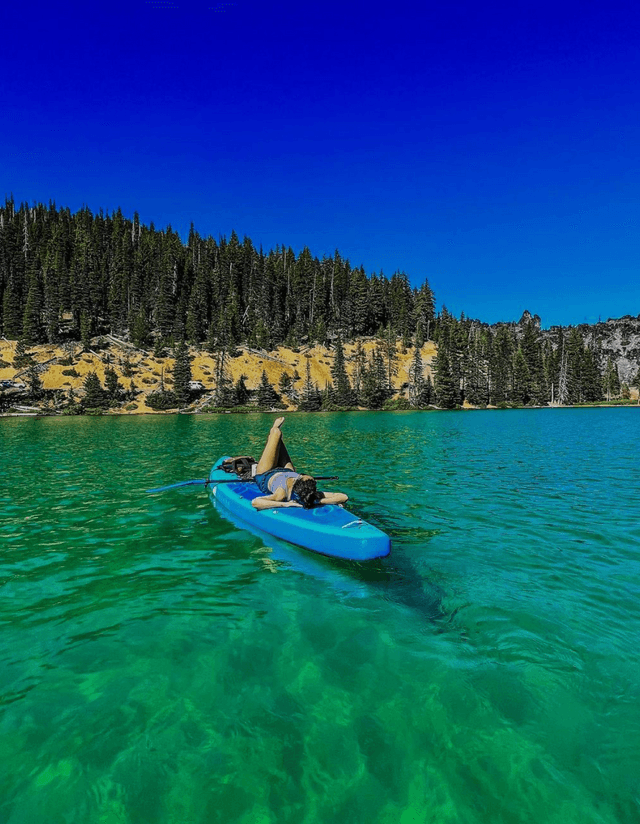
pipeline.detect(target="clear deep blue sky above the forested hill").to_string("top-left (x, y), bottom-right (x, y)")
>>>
top-left (0, 0), bottom-right (640, 326)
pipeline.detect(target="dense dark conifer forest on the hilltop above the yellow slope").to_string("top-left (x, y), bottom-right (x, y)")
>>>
top-left (0, 199), bottom-right (435, 349)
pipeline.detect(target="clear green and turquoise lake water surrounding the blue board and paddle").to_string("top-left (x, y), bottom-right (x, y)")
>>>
top-left (0, 409), bottom-right (640, 824)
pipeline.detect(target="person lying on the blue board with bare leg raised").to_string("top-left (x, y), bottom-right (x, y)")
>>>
top-left (251, 418), bottom-right (348, 509)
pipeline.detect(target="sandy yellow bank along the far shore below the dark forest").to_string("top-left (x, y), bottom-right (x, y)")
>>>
top-left (0, 337), bottom-right (640, 418)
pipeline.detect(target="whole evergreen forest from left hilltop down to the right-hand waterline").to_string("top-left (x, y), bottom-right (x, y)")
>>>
top-left (0, 200), bottom-right (640, 408)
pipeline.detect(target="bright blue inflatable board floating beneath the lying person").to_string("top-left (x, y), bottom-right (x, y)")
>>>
top-left (209, 456), bottom-right (391, 561)
